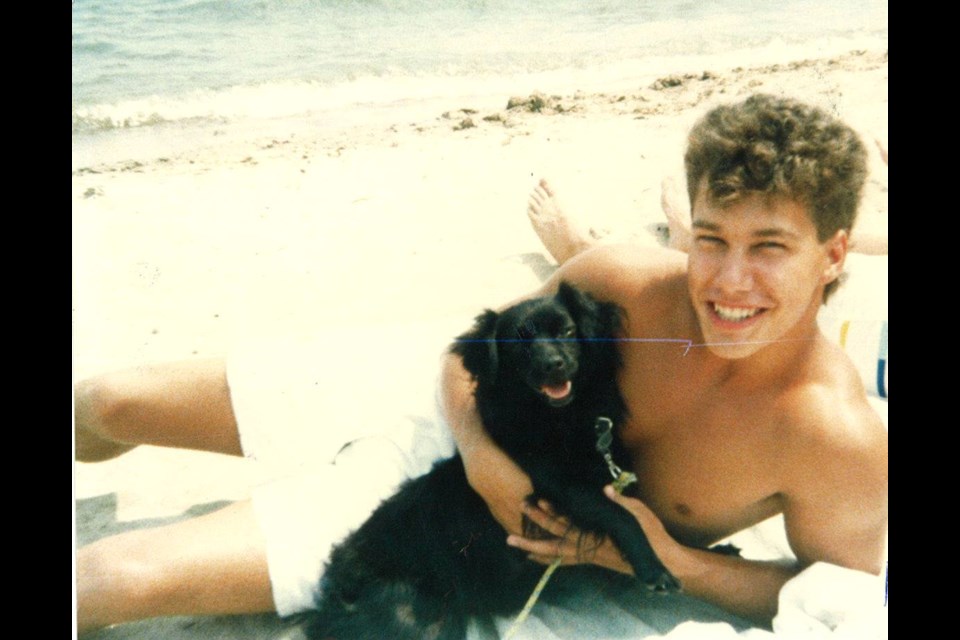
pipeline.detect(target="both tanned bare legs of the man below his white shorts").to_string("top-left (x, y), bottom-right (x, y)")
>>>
top-left (75, 360), bottom-right (273, 631)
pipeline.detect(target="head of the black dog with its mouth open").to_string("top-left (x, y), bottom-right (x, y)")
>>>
top-left (452, 282), bottom-right (620, 407)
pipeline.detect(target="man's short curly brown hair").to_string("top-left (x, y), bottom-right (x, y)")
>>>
top-left (684, 94), bottom-right (867, 300)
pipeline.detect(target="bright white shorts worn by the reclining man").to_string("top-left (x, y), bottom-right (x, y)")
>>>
top-left (227, 330), bottom-right (455, 616)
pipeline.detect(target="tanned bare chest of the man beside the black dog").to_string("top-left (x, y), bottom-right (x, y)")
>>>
top-left (621, 350), bottom-right (781, 545)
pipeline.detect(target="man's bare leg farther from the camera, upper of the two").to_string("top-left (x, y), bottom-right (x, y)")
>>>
top-left (74, 360), bottom-right (242, 462)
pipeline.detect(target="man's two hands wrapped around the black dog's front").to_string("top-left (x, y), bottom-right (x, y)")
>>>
top-left (507, 485), bottom-right (681, 575)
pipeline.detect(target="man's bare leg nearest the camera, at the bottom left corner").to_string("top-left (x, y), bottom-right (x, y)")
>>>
top-left (77, 501), bottom-right (274, 633)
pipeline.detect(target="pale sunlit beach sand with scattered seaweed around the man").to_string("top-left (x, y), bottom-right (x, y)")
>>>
top-left (72, 51), bottom-right (887, 639)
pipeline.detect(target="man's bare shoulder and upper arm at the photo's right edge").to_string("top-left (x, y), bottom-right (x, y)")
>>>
top-left (778, 345), bottom-right (888, 573)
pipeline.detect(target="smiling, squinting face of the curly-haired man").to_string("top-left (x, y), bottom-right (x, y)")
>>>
top-left (688, 186), bottom-right (846, 359)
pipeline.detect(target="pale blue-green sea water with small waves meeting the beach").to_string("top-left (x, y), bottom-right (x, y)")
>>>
top-left (72, 0), bottom-right (887, 143)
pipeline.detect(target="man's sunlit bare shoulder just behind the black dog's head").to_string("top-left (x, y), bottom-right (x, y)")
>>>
top-left (551, 244), bottom-right (687, 303)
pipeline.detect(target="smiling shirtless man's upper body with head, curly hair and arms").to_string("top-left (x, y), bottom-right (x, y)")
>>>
top-left (443, 96), bottom-right (887, 624)
